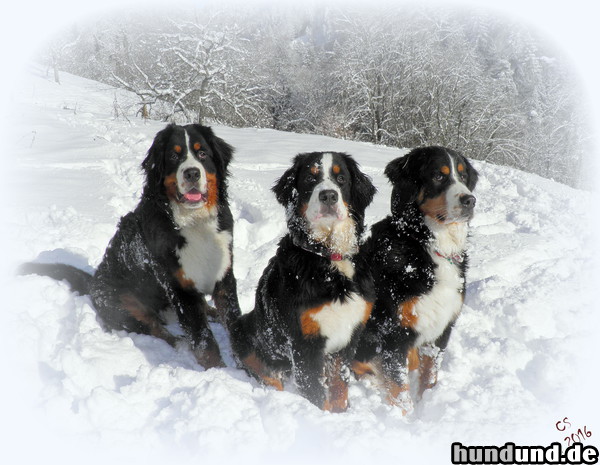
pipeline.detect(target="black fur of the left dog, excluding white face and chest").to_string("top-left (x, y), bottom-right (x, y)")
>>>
top-left (21, 125), bottom-right (240, 367)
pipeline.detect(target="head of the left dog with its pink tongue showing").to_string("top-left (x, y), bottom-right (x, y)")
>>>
top-left (142, 124), bottom-right (233, 216)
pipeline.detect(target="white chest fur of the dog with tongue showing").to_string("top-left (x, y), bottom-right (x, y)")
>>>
top-left (177, 220), bottom-right (232, 294)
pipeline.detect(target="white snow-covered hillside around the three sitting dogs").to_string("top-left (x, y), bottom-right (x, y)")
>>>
top-left (2, 66), bottom-right (600, 463)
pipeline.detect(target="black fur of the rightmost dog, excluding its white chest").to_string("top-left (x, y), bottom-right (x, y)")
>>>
top-left (355, 147), bottom-right (478, 407)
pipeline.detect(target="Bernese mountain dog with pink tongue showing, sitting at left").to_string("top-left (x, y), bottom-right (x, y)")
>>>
top-left (20, 124), bottom-right (240, 368)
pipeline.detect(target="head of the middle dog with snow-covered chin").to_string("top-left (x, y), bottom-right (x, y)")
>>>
top-left (273, 152), bottom-right (376, 254)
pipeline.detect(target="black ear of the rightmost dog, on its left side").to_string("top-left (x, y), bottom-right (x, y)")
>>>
top-left (385, 149), bottom-right (420, 209)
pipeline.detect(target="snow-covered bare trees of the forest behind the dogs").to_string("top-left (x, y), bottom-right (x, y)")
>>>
top-left (38, 4), bottom-right (591, 187)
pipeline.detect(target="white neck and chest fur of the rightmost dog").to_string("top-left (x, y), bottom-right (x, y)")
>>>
top-left (413, 224), bottom-right (467, 345)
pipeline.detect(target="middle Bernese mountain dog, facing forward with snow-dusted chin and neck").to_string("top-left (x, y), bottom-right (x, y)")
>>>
top-left (231, 152), bottom-right (376, 412)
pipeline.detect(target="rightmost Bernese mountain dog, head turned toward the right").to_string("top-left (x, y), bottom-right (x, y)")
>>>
top-left (352, 147), bottom-right (478, 413)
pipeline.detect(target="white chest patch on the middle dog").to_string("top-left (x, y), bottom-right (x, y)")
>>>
top-left (311, 293), bottom-right (369, 354)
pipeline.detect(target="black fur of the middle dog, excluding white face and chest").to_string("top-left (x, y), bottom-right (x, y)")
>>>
top-left (232, 152), bottom-right (375, 411)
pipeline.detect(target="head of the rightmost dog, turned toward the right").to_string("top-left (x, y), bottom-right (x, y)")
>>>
top-left (385, 147), bottom-right (478, 224)
